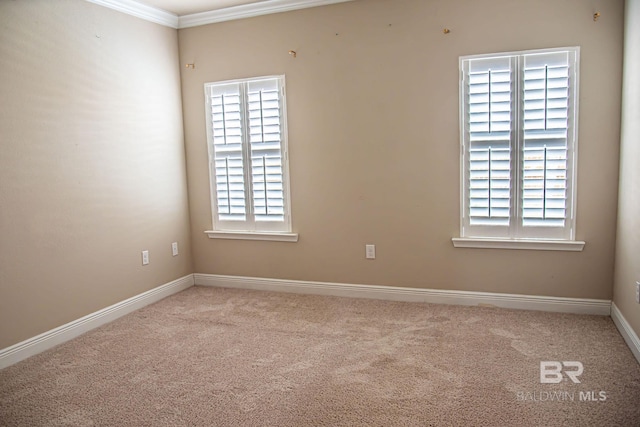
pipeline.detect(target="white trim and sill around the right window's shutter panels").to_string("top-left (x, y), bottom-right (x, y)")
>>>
top-left (452, 46), bottom-right (585, 247)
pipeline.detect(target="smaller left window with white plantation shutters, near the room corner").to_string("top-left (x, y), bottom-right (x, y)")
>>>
top-left (205, 76), bottom-right (291, 237)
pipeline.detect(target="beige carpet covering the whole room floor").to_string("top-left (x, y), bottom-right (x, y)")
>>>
top-left (0, 287), bottom-right (640, 426)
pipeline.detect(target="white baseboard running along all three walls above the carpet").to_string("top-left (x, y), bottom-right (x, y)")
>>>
top-left (0, 273), bottom-right (620, 369)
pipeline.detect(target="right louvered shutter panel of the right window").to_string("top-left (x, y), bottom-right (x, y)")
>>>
top-left (521, 52), bottom-right (572, 227)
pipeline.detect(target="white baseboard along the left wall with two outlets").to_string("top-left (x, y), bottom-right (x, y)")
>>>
top-left (0, 274), bottom-right (194, 369)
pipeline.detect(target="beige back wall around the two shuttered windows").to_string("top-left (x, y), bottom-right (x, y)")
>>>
top-left (178, 0), bottom-right (623, 299)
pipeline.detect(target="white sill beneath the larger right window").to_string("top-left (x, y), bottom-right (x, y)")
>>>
top-left (451, 237), bottom-right (585, 252)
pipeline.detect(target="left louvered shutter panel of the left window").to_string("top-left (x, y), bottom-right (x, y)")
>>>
top-left (210, 83), bottom-right (247, 221)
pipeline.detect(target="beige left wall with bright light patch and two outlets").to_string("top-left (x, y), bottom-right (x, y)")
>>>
top-left (0, 0), bottom-right (193, 348)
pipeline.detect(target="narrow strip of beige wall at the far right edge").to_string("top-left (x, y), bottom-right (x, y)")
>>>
top-left (613, 0), bottom-right (640, 342)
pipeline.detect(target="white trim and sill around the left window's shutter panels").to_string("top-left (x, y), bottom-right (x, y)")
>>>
top-left (204, 74), bottom-right (298, 237)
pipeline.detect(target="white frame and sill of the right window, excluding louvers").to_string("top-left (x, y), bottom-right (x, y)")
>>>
top-left (452, 47), bottom-right (584, 251)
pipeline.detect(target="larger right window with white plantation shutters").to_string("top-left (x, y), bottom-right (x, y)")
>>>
top-left (454, 48), bottom-right (579, 249)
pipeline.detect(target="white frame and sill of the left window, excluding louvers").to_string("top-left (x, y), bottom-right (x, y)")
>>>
top-left (204, 75), bottom-right (298, 242)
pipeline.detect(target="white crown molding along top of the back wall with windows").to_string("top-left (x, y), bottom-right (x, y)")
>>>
top-left (178, 0), bottom-right (353, 28)
